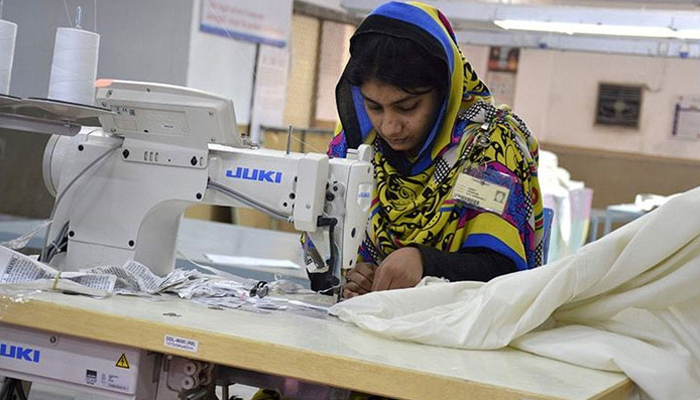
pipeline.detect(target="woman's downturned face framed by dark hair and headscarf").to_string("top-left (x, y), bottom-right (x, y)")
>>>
top-left (360, 78), bottom-right (439, 156)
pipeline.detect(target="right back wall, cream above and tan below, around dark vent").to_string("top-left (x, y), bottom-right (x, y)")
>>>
top-left (514, 49), bottom-right (700, 208)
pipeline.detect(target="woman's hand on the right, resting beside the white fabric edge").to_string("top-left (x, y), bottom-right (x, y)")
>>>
top-left (372, 247), bottom-right (423, 292)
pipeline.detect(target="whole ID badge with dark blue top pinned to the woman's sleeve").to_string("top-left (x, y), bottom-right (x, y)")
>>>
top-left (452, 168), bottom-right (518, 215)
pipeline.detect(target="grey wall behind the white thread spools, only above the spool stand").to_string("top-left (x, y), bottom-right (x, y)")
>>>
top-left (3, 0), bottom-right (192, 97)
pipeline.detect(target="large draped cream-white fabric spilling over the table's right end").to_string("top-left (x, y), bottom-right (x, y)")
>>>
top-left (330, 188), bottom-right (700, 400)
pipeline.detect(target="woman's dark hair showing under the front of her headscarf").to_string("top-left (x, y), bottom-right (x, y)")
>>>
top-left (345, 33), bottom-right (449, 95)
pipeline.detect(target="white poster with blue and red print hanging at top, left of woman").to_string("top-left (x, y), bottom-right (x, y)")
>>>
top-left (199, 0), bottom-right (293, 47)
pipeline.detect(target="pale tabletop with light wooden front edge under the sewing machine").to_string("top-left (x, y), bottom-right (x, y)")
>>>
top-left (0, 289), bottom-right (633, 399)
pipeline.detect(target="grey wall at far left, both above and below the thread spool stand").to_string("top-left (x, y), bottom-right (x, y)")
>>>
top-left (0, 0), bottom-right (192, 218)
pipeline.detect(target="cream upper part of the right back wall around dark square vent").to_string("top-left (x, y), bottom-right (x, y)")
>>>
top-left (515, 49), bottom-right (700, 160)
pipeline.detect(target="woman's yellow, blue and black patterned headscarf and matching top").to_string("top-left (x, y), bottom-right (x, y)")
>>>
top-left (329, 2), bottom-right (543, 269)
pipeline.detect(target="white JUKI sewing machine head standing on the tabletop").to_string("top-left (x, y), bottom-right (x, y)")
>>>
top-left (42, 80), bottom-right (373, 294)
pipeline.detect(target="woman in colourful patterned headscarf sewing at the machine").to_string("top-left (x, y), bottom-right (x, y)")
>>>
top-left (329, 2), bottom-right (543, 297)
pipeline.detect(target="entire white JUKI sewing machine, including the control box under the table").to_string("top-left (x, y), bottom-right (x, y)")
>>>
top-left (0, 80), bottom-right (373, 399)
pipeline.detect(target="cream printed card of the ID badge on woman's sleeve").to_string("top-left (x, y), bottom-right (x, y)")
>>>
top-left (453, 173), bottom-right (510, 214)
